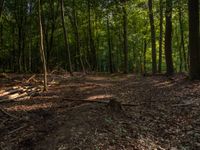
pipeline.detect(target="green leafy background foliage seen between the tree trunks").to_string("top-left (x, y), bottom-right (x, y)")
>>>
top-left (0, 0), bottom-right (188, 72)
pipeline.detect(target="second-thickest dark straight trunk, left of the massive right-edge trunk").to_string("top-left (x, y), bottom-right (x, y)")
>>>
top-left (165, 0), bottom-right (174, 75)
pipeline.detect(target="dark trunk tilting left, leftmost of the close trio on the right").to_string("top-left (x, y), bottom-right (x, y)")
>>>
top-left (148, 0), bottom-right (157, 74)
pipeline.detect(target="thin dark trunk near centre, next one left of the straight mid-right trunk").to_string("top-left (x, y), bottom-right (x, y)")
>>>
top-left (107, 14), bottom-right (113, 73)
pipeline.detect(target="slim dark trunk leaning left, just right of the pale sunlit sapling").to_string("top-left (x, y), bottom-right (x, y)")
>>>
top-left (61, 0), bottom-right (73, 75)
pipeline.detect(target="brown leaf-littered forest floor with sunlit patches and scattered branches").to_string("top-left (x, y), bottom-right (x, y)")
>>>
top-left (0, 73), bottom-right (200, 150)
